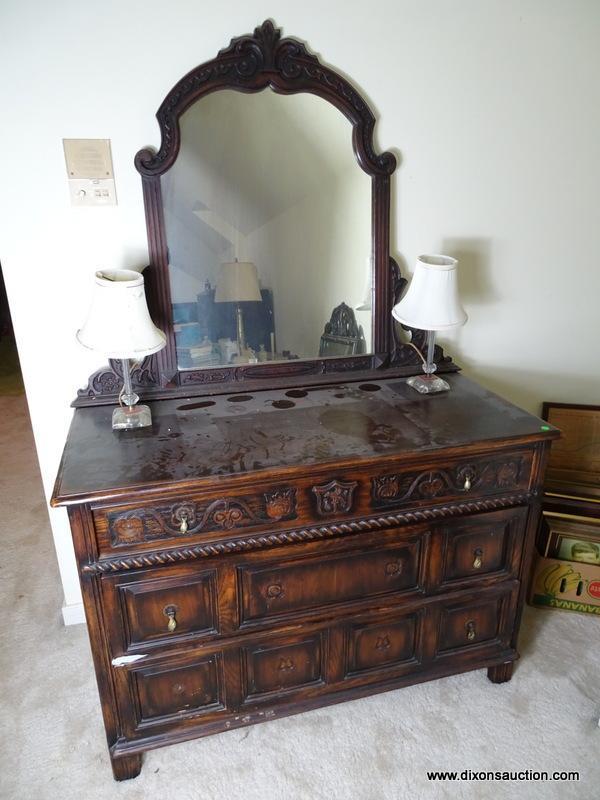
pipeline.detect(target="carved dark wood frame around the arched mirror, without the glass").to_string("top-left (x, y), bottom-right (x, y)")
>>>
top-left (73, 20), bottom-right (456, 406)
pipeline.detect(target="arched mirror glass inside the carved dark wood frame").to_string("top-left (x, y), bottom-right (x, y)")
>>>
top-left (161, 89), bottom-right (372, 370)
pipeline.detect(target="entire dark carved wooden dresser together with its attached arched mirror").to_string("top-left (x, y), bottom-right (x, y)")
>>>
top-left (52, 22), bottom-right (557, 780)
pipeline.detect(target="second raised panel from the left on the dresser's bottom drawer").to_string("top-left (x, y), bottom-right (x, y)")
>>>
top-left (242, 633), bottom-right (326, 702)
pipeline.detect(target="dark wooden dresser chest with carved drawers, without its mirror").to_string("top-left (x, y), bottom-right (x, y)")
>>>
top-left (52, 374), bottom-right (557, 780)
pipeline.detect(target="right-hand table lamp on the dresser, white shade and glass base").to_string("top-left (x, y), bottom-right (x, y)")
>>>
top-left (392, 255), bottom-right (467, 394)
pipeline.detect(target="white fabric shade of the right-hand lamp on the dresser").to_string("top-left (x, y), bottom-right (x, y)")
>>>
top-left (392, 255), bottom-right (467, 331)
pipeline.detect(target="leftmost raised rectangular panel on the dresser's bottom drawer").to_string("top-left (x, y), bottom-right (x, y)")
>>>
top-left (124, 653), bottom-right (225, 732)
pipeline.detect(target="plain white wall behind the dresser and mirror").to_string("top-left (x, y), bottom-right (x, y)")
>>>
top-left (0, 0), bottom-right (600, 610)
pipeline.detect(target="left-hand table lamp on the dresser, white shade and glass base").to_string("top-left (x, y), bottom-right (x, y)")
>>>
top-left (77, 269), bottom-right (167, 430)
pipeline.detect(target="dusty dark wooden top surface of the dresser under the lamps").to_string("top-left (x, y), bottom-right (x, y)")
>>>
top-left (52, 375), bottom-right (557, 505)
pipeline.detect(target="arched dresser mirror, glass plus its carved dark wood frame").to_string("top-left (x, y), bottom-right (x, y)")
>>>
top-left (75, 21), bottom-right (453, 405)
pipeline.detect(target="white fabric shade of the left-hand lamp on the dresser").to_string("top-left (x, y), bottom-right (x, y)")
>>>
top-left (77, 269), bottom-right (167, 360)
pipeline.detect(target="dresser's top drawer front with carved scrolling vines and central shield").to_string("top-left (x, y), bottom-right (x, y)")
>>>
top-left (92, 450), bottom-right (533, 560)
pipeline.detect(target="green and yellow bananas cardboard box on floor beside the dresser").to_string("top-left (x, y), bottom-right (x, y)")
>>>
top-left (529, 555), bottom-right (600, 614)
